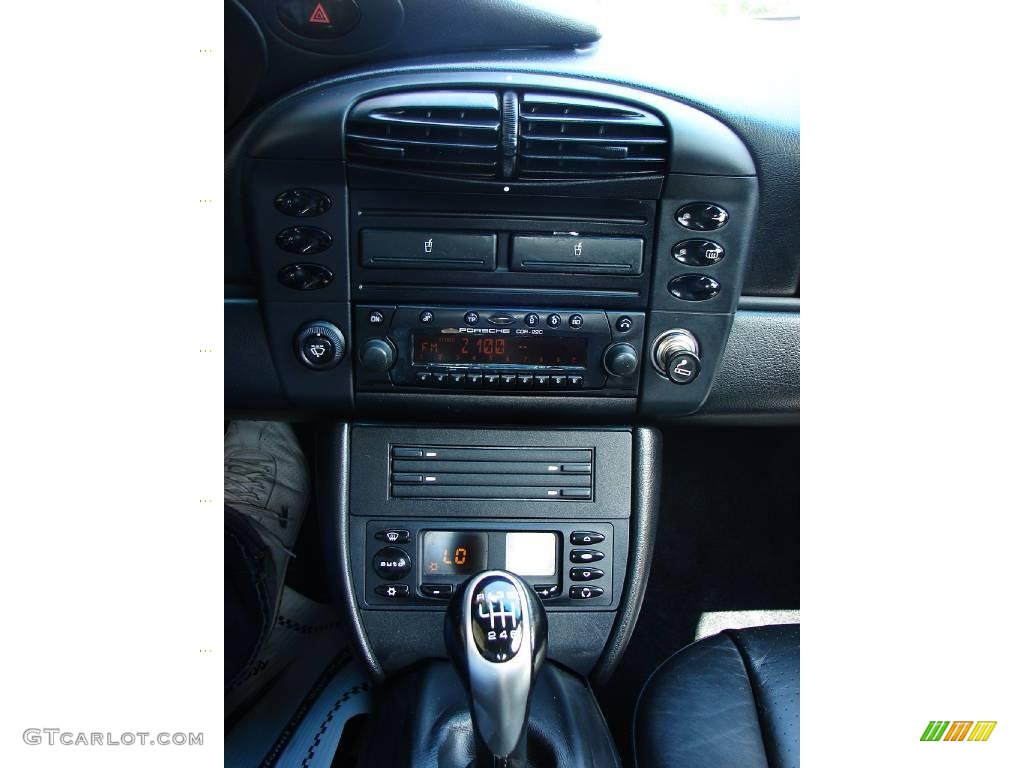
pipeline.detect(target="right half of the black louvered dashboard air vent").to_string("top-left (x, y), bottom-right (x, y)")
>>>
top-left (518, 93), bottom-right (669, 179)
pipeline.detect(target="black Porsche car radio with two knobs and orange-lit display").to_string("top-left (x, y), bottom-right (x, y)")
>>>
top-left (354, 306), bottom-right (644, 396)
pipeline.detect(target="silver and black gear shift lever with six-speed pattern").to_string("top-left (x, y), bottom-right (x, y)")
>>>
top-left (444, 570), bottom-right (548, 768)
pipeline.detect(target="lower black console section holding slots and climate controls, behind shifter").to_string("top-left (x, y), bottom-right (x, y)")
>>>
top-left (326, 424), bottom-right (656, 674)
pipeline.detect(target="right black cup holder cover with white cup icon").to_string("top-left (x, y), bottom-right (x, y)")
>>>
top-left (509, 234), bottom-right (643, 274)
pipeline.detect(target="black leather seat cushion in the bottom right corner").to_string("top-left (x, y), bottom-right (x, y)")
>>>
top-left (633, 625), bottom-right (800, 768)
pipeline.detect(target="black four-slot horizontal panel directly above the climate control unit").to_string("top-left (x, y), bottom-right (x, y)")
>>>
top-left (390, 445), bottom-right (594, 502)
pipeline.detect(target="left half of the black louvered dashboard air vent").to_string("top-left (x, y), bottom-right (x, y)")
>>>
top-left (345, 90), bottom-right (502, 178)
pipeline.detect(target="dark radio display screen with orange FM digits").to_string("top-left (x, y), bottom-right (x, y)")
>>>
top-left (413, 331), bottom-right (587, 368)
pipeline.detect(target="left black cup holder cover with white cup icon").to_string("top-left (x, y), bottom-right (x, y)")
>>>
top-left (360, 229), bottom-right (498, 271)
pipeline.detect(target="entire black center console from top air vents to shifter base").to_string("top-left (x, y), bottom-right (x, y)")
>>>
top-left (227, 67), bottom-right (758, 766)
